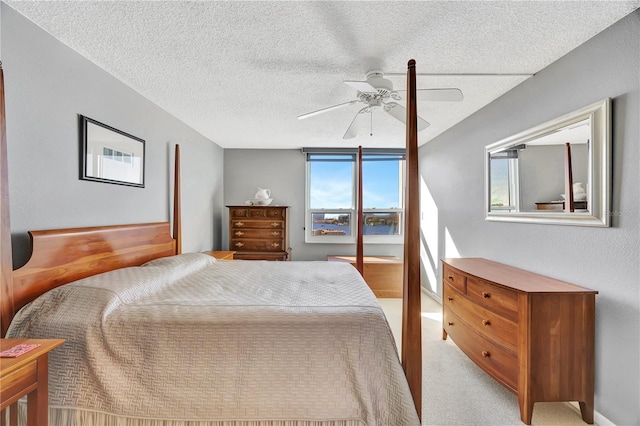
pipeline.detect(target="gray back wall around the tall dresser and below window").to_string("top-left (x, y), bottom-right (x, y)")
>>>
top-left (223, 149), bottom-right (403, 260)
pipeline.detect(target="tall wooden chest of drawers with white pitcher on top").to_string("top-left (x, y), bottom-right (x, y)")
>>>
top-left (227, 206), bottom-right (291, 260)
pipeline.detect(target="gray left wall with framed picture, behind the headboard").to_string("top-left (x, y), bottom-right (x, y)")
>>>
top-left (1, 3), bottom-right (223, 266)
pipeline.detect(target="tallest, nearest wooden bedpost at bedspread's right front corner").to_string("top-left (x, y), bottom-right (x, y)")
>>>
top-left (402, 59), bottom-right (422, 419)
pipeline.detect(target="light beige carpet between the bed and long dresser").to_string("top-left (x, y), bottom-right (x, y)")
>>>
top-left (378, 293), bottom-right (586, 426)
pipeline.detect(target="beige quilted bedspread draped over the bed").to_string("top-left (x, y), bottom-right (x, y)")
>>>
top-left (8, 253), bottom-right (419, 426)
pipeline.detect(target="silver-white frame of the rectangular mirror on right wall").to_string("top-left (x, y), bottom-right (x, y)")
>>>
top-left (484, 98), bottom-right (611, 227)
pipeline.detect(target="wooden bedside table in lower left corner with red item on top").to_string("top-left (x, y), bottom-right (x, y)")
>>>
top-left (0, 339), bottom-right (64, 425)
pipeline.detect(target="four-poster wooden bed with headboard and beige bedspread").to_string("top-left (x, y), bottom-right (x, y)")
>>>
top-left (0, 61), bottom-right (421, 426)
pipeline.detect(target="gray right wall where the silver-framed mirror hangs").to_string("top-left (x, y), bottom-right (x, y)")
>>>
top-left (418, 11), bottom-right (640, 425)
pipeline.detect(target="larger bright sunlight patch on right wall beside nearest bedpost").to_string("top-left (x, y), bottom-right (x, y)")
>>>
top-left (420, 176), bottom-right (438, 293)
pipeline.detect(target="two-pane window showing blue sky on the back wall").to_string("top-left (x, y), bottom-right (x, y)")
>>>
top-left (303, 148), bottom-right (404, 244)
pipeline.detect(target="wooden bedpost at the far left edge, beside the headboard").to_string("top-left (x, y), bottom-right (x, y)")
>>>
top-left (0, 62), bottom-right (13, 337)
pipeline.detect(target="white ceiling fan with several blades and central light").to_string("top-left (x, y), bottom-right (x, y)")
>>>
top-left (298, 70), bottom-right (462, 139)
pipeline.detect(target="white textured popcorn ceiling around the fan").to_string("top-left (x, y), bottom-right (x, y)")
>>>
top-left (6, 0), bottom-right (640, 148)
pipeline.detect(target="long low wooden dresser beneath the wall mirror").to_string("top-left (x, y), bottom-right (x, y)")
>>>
top-left (442, 258), bottom-right (597, 424)
